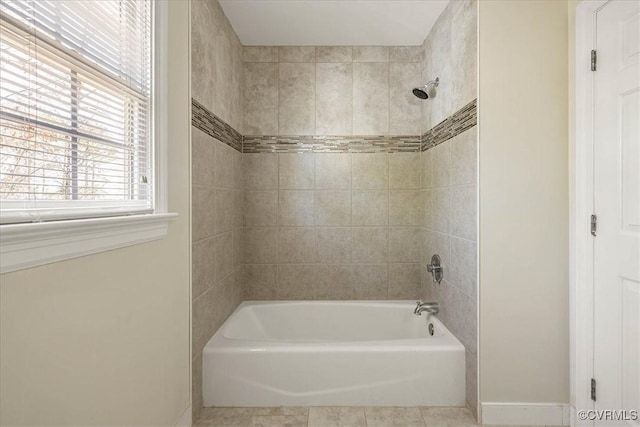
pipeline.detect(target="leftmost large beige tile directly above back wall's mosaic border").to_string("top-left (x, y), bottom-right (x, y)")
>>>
top-left (242, 63), bottom-right (278, 135)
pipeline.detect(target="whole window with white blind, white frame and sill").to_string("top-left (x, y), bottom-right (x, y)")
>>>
top-left (0, 0), bottom-right (177, 273)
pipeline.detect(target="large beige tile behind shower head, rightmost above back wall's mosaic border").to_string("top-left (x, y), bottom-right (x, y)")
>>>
top-left (389, 62), bottom-right (426, 135)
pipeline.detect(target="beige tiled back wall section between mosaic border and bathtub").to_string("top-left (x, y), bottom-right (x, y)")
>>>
top-left (243, 152), bottom-right (422, 300)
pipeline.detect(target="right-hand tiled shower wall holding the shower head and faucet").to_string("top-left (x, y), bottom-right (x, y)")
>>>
top-left (421, 0), bottom-right (478, 412)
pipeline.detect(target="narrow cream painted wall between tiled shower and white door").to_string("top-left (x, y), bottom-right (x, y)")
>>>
top-left (479, 0), bottom-right (569, 403)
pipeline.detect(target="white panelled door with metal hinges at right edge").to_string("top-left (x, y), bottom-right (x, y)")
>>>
top-left (593, 0), bottom-right (640, 426)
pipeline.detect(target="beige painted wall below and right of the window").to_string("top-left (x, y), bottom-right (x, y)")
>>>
top-left (0, 2), bottom-right (190, 426)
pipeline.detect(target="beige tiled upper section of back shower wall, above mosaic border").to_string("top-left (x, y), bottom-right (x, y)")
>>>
top-left (243, 46), bottom-right (423, 135)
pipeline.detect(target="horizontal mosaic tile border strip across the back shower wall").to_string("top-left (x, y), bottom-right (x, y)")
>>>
top-left (242, 136), bottom-right (420, 153)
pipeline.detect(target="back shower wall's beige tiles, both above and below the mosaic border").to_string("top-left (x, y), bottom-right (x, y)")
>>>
top-left (243, 46), bottom-right (423, 300)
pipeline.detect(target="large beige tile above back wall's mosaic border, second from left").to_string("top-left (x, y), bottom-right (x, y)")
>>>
top-left (278, 63), bottom-right (316, 135)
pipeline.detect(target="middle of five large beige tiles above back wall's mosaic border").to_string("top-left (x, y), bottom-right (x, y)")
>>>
top-left (315, 62), bottom-right (353, 135)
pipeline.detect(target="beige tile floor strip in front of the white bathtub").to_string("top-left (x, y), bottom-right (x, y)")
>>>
top-left (193, 407), bottom-right (556, 427)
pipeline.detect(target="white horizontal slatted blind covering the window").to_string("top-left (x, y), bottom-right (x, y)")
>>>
top-left (0, 0), bottom-right (153, 223)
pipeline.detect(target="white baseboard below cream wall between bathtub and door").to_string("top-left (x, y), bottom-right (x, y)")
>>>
top-left (481, 402), bottom-right (570, 426)
